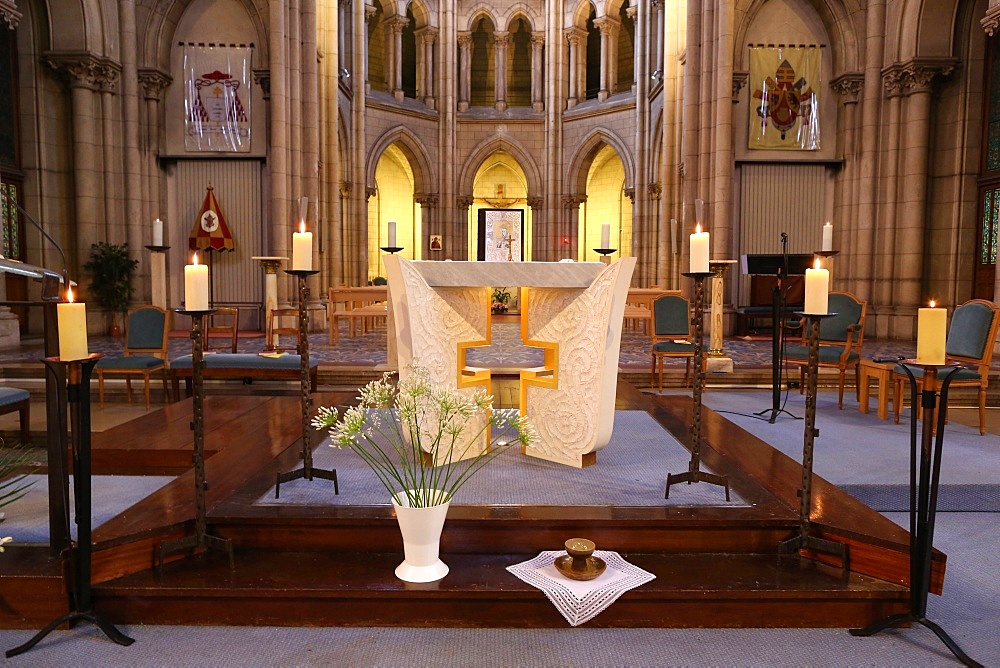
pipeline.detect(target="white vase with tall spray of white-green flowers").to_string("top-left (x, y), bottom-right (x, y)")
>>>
top-left (312, 366), bottom-right (536, 582)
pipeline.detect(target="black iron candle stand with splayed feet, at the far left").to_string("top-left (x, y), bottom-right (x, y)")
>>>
top-left (6, 353), bottom-right (135, 658)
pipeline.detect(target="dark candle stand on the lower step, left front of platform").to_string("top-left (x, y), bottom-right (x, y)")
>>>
top-left (158, 309), bottom-right (236, 569)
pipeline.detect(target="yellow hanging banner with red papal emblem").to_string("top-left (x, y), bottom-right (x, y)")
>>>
top-left (749, 46), bottom-right (822, 151)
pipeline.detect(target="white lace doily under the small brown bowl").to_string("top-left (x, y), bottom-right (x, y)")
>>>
top-left (507, 550), bottom-right (656, 626)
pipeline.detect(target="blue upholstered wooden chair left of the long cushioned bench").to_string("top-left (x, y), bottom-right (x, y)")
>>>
top-left (97, 306), bottom-right (167, 410)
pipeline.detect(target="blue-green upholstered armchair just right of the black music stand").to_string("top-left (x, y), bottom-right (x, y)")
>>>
top-left (784, 290), bottom-right (868, 410)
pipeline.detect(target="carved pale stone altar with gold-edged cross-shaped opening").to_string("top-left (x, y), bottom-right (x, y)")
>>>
top-left (385, 256), bottom-right (636, 467)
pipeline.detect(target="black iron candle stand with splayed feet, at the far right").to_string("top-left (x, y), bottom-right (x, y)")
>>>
top-left (850, 360), bottom-right (982, 666)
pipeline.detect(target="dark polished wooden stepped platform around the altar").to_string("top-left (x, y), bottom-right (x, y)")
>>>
top-left (0, 383), bottom-right (944, 628)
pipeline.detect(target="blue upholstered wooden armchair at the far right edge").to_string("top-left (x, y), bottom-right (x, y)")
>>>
top-left (892, 299), bottom-right (1000, 434)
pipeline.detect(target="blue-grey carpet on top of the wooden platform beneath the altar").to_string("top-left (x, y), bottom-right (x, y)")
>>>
top-left (257, 411), bottom-right (746, 506)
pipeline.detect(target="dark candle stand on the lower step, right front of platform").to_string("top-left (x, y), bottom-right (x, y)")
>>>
top-left (778, 313), bottom-right (848, 570)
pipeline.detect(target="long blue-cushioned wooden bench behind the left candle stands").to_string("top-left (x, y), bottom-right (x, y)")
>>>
top-left (170, 353), bottom-right (319, 401)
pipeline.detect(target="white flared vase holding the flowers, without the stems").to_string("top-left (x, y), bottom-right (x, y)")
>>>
top-left (392, 490), bottom-right (451, 582)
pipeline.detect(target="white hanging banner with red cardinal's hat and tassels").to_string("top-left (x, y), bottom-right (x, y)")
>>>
top-left (184, 43), bottom-right (253, 153)
